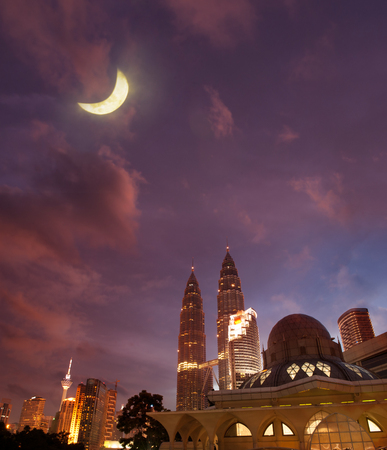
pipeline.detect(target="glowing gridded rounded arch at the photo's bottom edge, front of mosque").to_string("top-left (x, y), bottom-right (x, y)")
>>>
top-left (309, 413), bottom-right (375, 450)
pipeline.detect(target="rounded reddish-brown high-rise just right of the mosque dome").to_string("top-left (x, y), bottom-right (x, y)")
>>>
top-left (337, 308), bottom-right (375, 350)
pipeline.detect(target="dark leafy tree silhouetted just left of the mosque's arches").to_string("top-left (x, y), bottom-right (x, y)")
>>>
top-left (117, 391), bottom-right (169, 450)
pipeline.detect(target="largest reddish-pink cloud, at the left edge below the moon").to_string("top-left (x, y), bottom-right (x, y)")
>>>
top-left (0, 122), bottom-right (143, 263)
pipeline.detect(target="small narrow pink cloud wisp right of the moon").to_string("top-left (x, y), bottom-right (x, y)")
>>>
top-left (204, 86), bottom-right (234, 139)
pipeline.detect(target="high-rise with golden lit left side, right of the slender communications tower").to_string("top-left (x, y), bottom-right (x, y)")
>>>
top-left (75, 378), bottom-right (107, 450)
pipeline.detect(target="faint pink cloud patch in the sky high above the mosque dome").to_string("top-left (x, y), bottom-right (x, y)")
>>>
top-left (290, 174), bottom-right (348, 222)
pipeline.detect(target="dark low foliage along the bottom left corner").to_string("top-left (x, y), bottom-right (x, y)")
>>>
top-left (0, 422), bottom-right (85, 450)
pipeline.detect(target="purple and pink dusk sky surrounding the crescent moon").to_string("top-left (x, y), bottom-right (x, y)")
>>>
top-left (0, 0), bottom-right (387, 422)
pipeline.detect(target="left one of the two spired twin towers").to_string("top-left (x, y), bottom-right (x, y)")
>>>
top-left (176, 267), bottom-right (212, 411)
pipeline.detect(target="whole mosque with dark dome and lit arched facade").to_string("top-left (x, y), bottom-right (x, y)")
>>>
top-left (150, 314), bottom-right (387, 450)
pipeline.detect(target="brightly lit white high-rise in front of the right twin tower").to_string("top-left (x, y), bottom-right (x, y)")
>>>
top-left (228, 308), bottom-right (262, 389)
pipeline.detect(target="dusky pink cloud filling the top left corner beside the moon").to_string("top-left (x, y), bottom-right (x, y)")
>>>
top-left (0, 0), bottom-right (111, 96)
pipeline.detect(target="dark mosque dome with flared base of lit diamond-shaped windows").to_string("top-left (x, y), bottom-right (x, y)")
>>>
top-left (241, 314), bottom-right (378, 389)
